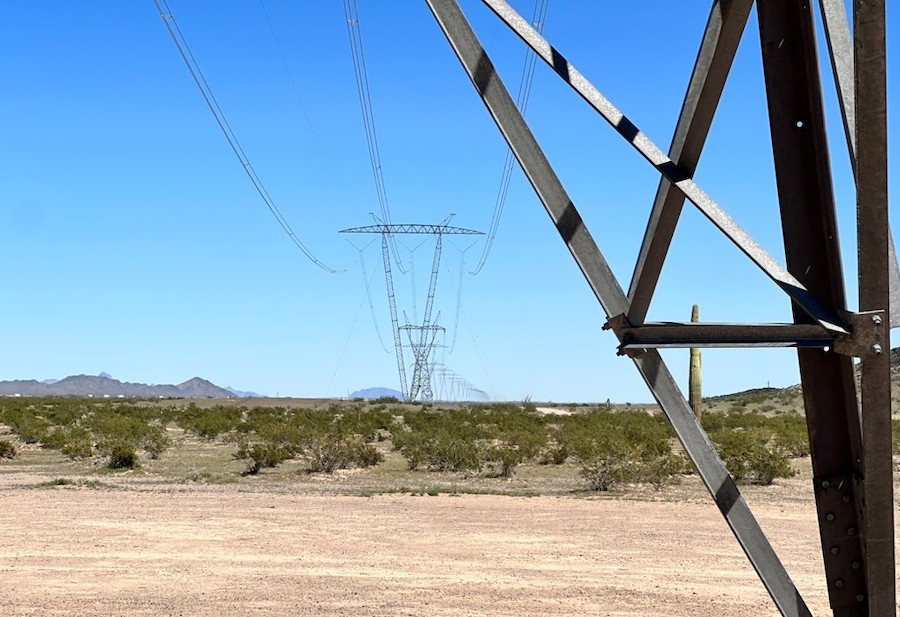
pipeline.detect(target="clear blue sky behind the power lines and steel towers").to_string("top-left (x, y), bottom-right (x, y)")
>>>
top-left (0, 0), bottom-right (900, 402)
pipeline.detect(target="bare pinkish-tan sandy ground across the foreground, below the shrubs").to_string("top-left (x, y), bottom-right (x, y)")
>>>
top-left (0, 477), bottom-right (844, 617)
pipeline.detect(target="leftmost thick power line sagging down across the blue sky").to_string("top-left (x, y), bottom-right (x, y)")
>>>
top-left (153, 0), bottom-right (337, 274)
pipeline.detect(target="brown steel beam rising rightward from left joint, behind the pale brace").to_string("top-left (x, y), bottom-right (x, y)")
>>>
top-left (628, 0), bottom-right (753, 325)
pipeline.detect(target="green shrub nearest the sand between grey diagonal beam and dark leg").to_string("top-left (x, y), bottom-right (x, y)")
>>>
top-left (710, 429), bottom-right (794, 486)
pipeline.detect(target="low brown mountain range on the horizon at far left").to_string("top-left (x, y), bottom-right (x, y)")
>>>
top-left (0, 373), bottom-right (253, 398)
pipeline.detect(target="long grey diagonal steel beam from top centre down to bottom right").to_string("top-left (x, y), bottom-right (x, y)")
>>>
top-left (426, 0), bottom-right (810, 617)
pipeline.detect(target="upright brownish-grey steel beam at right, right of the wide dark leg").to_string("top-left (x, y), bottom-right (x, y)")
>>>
top-left (853, 0), bottom-right (897, 617)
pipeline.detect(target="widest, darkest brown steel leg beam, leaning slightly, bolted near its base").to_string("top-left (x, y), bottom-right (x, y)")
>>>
top-left (757, 0), bottom-right (868, 617)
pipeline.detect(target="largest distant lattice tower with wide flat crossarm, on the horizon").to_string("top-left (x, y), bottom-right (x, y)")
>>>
top-left (340, 214), bottom-right (483, 401)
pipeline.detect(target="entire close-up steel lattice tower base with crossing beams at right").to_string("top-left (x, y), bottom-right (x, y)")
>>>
top-left (425, 0), bottom-right (900, 617)
